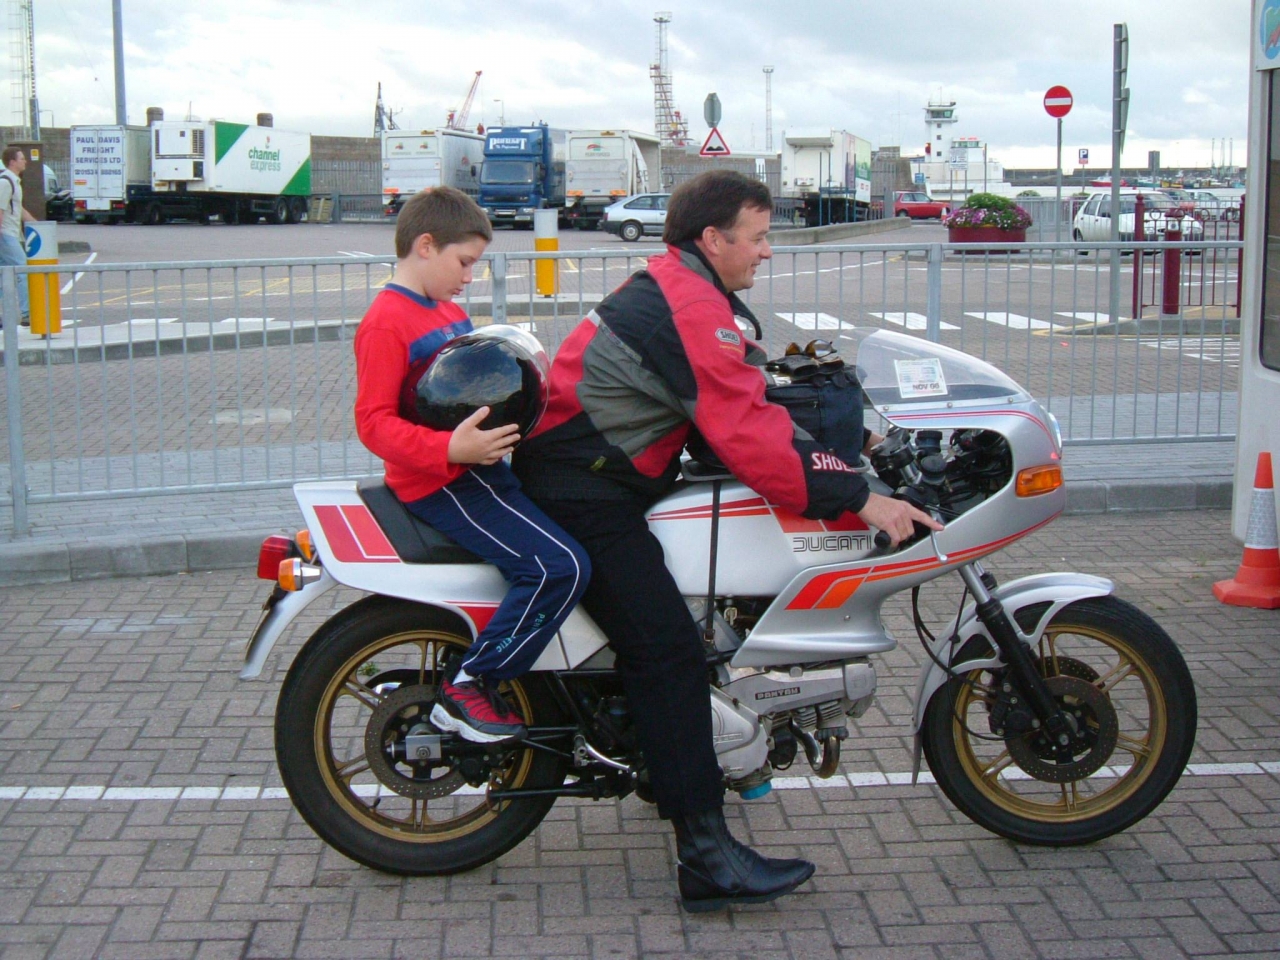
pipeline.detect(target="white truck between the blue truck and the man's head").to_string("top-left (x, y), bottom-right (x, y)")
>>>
top-left (564, 131), bottom-right (662, 230)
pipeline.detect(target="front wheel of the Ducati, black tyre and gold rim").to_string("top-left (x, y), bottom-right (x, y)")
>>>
top-left (920, 596), bottom-right (1196, 846)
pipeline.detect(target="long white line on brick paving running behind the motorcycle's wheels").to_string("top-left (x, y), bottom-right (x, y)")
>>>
top-left (0, 760), bottom-right (1280, 803)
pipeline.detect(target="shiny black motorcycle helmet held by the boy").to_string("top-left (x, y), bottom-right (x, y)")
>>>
top-left (401, 324), bottom-right (550, 436)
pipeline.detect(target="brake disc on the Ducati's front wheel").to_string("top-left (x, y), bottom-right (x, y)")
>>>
top-left (1005, 664), bottom-right (1120, 783)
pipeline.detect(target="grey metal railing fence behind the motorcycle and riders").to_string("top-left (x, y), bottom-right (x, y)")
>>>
top-left (0, 242), bottom-right (1242, 534)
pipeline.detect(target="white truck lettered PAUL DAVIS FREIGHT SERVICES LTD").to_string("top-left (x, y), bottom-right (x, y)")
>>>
top-left (70, 124), bottom-right (151, 223)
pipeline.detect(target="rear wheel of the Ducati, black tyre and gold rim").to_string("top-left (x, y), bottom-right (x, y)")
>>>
top-left (275, 596), bottom-right (568, 876)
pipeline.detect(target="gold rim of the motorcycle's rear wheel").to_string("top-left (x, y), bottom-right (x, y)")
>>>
top-left (312, 630), bottom-right (532, 844)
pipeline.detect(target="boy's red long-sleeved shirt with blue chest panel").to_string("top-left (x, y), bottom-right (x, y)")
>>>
top-left (356, 284), bottom-right (474, 502)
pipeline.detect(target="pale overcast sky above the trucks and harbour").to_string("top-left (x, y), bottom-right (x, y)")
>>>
top-left (12, 0), bottom-right (1251, 168)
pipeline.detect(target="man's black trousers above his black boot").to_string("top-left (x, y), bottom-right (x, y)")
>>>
top-left (538, 499), bottom-right (724, 819)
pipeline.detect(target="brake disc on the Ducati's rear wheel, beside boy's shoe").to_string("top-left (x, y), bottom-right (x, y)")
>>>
top-left (365, 684), bottom-right (466, 800)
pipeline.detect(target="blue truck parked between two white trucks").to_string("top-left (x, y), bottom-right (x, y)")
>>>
top-left (480, 123), bottom-right (566, 227)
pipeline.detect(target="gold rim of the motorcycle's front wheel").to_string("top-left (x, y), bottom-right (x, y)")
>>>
top-left (951, 625), bottom-right (1169, 823)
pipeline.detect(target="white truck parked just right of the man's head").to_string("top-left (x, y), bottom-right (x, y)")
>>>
top-left (778, 128), bottom-right (872, 227)
